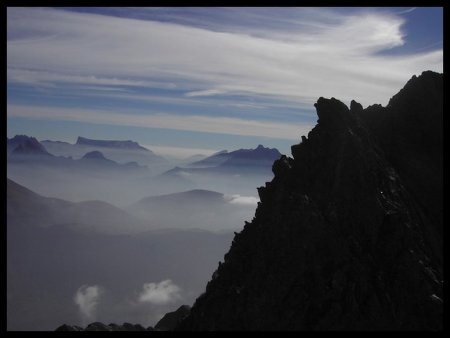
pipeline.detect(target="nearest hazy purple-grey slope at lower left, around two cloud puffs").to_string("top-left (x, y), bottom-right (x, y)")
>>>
top-left (7, 179), bottom-right (236, 331)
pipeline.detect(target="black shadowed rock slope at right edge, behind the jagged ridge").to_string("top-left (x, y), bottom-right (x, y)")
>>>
top-left (361, 71), bottom-right (444, 264)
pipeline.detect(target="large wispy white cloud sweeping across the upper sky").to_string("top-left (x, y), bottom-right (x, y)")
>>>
top-left (7, 8), bottom-right (443, 105)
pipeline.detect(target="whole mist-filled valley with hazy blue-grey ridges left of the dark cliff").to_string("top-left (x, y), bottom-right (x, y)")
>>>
top-left (7, 135), bottom-right (279, 330)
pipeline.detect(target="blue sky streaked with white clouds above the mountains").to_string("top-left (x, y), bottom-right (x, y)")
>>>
top-left (7, 7), bottom-right (443, 158)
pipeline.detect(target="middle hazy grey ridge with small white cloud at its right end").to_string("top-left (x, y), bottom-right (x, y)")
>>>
top-left (7, 179), bottom-right (253, 234)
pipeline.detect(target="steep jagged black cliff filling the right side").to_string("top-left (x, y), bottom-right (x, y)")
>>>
top-left (177, 72), bottom-right (443, 330)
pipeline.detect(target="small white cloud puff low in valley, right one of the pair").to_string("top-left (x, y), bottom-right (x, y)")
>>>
top-left (138, 279), bottom-right (181, 305)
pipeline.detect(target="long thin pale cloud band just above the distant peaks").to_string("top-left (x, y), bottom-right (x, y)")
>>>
top-left (7, 104), bottom-right (313, 140)
